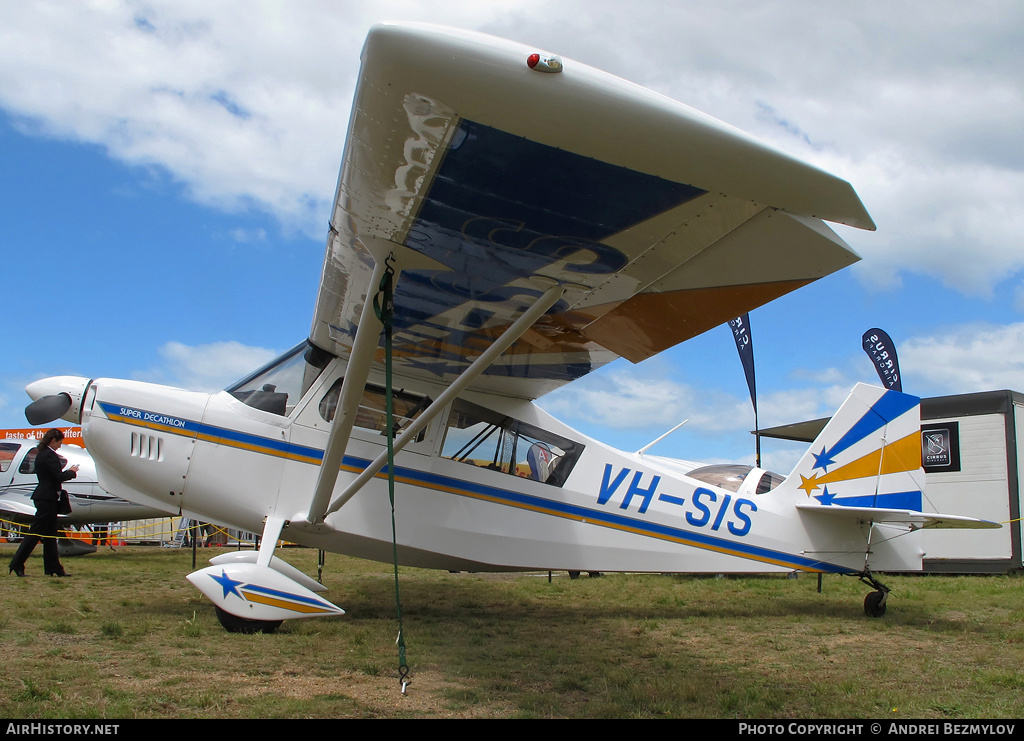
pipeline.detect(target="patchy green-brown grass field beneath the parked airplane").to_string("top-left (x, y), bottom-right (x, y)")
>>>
top-left (0, 544), bottom-right (1024, 718)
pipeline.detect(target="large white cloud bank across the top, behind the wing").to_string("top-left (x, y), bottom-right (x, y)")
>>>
top-left (0, 0), bottom-right (1024, 295)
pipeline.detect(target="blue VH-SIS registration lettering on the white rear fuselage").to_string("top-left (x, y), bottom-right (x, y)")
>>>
top-left (597, 464), bottom-right (758, 537)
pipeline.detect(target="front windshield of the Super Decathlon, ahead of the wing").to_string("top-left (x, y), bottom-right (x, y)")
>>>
top-left (227, 342), bottom-right (332, 417)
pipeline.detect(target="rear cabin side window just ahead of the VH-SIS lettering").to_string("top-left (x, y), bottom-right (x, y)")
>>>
top-left (441, 399), bottom-right (584, 486)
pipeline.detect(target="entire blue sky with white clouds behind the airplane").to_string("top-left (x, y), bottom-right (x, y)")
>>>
top-left (0, 0), bottom-right (1024, 472)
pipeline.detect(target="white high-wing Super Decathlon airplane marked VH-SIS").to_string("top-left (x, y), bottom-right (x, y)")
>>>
top-left (27, 24), bottom-right (991, 630)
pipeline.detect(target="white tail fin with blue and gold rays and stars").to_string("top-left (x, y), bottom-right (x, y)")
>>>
top-left (775, 384), bottom-right (925, 512)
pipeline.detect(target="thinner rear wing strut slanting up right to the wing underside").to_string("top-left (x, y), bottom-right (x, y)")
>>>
top-left (323, 286), bottom-right (565, 519)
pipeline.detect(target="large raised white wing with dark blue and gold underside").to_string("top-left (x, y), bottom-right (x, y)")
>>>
top-left (310, 25), bottom-right (874, 398)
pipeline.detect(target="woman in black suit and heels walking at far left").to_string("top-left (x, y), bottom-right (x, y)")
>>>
top-left (10, 429), bottom-right (78, 576)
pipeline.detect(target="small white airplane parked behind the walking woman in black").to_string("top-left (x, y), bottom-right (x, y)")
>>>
top-left (0, 438), bottom-right (176, 556)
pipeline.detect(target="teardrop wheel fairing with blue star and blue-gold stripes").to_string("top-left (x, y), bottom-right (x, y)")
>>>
top-left (187, 563), bottom-right (345, 621)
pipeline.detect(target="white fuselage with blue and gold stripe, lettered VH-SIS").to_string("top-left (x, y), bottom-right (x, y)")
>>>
top-left (44, 345), bottom-right (920, 572)
